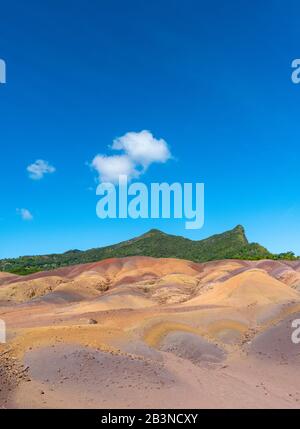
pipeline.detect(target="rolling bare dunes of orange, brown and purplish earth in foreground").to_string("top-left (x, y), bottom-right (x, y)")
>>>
top-left (0, 257), bottom-right (300, 408)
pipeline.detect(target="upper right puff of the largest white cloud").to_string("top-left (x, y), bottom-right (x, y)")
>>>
top-left (112, 130), bottom-right (171, 168)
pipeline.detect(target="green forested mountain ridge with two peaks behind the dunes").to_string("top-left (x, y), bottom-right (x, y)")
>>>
top-left (0, 225), bottom-right (298, 274)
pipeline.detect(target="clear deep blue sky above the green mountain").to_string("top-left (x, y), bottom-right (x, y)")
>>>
top-left (0, 0), bottom-right (300, 258)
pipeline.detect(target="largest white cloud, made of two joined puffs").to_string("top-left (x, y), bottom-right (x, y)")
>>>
top-left (91, 130), bottom-right (172, 183)
